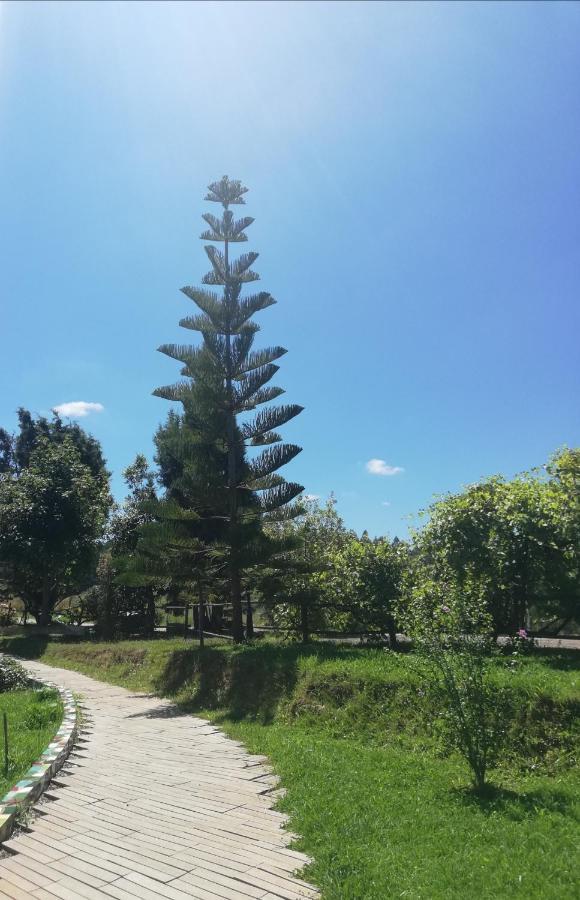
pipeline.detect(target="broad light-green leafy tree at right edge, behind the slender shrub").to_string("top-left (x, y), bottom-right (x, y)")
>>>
top-left (410, 451), bottom-right (580, 635)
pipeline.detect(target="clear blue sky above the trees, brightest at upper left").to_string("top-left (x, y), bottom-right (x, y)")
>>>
top-left (0, 2), bottom-right (580, 536)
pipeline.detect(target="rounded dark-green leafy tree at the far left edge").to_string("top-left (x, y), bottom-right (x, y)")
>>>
top-left (0, 435), bottom-right (111, 625)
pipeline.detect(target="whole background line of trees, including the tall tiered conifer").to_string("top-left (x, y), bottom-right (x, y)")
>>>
top-left (0, 176), bottom-right (580, 647)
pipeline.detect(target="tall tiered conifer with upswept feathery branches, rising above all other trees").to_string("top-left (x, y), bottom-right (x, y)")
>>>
top-left (155, 176), bottom-right (302, 641)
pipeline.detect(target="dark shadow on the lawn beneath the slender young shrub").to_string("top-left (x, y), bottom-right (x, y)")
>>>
top-left (451, 784), bottom-right (580, 822)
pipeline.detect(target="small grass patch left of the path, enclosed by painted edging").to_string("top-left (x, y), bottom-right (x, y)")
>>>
top-left (0, 689), bottom-right (63, 797)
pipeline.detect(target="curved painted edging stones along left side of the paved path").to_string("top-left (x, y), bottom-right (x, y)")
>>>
top-left (0, 681), bottom-right (77, 844)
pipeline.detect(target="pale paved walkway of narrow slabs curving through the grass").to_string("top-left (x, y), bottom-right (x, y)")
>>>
top-left (0, 663), bottom-right (318, 900)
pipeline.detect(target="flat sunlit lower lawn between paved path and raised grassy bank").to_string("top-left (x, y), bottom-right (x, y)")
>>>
top-left (227, 719), bottom-right (580, 900)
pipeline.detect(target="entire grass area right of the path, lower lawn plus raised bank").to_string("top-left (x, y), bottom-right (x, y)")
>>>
top-left (2, 638), bottom-right (580, 900)
